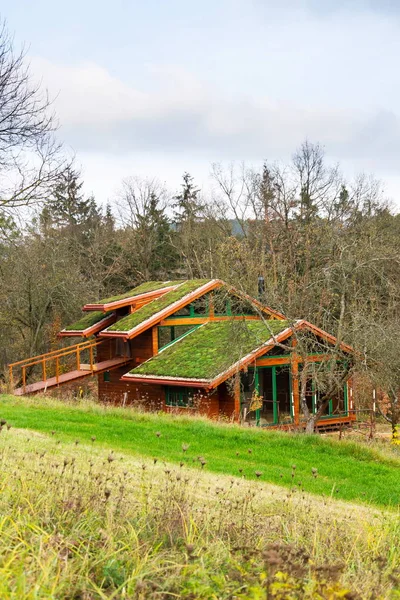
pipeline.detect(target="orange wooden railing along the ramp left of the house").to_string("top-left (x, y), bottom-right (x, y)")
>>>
top-left (8, 340), bottom-right (103, 392)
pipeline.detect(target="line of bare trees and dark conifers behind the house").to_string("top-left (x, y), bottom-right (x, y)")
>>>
top-left (0, 142), bottom-right (400, 365)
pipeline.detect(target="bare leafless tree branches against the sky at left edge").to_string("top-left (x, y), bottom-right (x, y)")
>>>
top-left (0, 22), bottom-right (65, 227)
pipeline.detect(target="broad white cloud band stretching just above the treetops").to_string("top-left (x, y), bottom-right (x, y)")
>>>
top-left (32, 58), bottom-right (400, 206)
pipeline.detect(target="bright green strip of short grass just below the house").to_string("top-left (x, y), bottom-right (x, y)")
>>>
top-left (0, 395), bottom-right (400, 507)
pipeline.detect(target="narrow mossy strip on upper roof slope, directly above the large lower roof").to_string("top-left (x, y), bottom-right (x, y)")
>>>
top-left (107, 279), bottom-right (211, 332)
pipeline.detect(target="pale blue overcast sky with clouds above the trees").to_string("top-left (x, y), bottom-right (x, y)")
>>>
top-left (1, 0), bottom-right (400, 206)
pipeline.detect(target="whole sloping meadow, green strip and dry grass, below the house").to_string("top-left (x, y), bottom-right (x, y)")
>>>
top-left (0, 396), bottom-right (400, 600)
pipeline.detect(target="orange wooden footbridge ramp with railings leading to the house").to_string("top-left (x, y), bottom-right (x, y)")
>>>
top-left (9, 340), bottom-right (130, 396)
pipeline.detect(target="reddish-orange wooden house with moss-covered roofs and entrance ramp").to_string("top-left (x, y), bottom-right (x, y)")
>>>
top-left (10, 279), bottom-right (355, 427)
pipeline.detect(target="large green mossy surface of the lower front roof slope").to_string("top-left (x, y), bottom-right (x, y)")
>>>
top-left (130, 320), bottom-right (288, 380)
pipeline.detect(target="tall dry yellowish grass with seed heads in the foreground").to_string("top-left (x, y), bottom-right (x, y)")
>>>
top-left (0, 426), bottom-right (400, 600)
